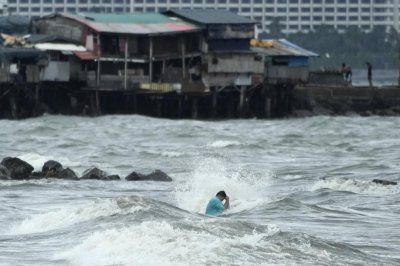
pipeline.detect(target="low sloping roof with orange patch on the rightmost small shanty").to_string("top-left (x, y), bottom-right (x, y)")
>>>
top-left (251, 39), bottom-right (319, 57)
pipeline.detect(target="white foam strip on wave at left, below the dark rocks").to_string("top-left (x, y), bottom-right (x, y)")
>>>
top-left (10, 199), bottom-right (142, 234)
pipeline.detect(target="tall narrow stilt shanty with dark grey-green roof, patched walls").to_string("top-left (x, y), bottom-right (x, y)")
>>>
top-left (166, 9), bottom-right (264, 116)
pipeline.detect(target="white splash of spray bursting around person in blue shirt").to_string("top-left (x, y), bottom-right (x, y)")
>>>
top-left (175, 158), bottom-right (272, 213)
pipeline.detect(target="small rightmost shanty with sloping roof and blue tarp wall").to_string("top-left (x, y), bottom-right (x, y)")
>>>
top-left (251, 39), bottom-right (318, 84)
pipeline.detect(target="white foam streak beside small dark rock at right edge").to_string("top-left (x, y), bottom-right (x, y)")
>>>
top-left (311, 177), bottom-right (400, 195)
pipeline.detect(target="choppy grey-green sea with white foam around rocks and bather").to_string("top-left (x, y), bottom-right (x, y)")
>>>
top-left (0, 115), bottom-right (400, 266)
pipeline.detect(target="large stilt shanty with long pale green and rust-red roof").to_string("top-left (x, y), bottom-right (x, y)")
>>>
top-left (34, 13), bottom-right (201, 90)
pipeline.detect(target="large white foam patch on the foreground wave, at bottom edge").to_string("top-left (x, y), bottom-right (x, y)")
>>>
top-left (56, 221), bottom-right (276, 266)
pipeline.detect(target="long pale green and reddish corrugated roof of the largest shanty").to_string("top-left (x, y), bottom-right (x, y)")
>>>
top-left (62, 13), bottom-right (201, 35)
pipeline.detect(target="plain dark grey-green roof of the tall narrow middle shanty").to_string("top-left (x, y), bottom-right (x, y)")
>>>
top-left (166, 9), bottom-right (256, 24)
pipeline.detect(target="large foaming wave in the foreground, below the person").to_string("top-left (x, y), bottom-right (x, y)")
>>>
top-left (55, 218), bottom-right (394, 266)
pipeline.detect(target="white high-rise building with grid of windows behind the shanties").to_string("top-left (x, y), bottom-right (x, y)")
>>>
top-left (3, 0), bottom-right (400, 33)
